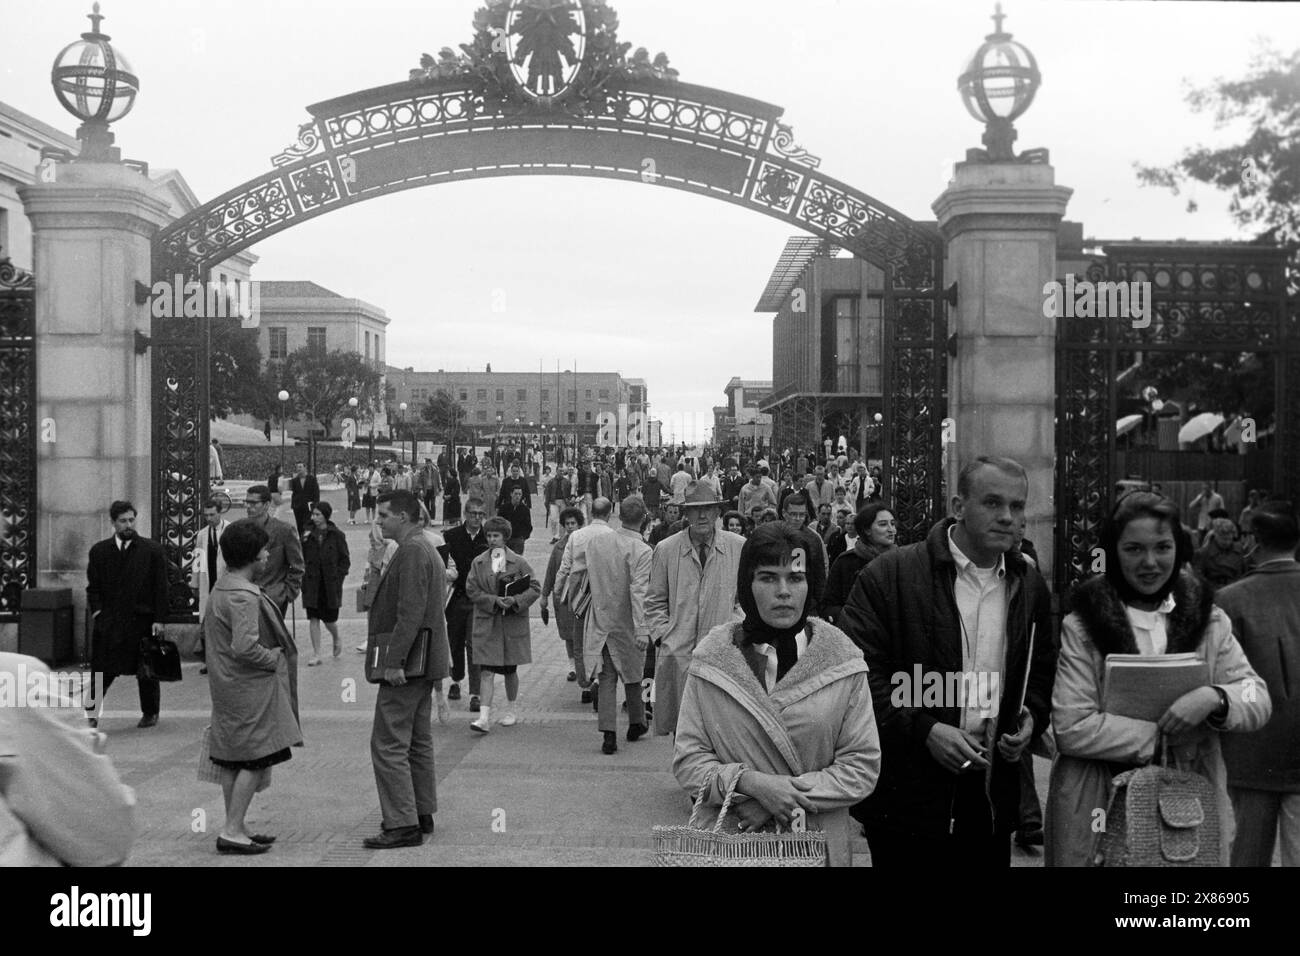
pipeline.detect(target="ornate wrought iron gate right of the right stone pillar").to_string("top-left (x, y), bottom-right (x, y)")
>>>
top-left (1054, 242), bottom-right (1300, 594)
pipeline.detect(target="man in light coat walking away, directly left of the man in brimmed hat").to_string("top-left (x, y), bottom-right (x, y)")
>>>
top-left (582, 496), bottom-right (654, 754)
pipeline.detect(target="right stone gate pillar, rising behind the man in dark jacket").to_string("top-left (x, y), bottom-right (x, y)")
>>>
top-left (932, 161), bottom-right (1073, 581)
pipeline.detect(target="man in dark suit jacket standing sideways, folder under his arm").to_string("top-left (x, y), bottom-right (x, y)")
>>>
top-left (364, 490), bottom-right (451, 849)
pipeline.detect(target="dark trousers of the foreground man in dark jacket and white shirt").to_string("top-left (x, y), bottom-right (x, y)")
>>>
top-left (866, 773), bottom-right (1011, 873)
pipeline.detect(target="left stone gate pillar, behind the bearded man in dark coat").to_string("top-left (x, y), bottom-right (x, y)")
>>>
top-left (18, 163), bottom-right (172, 655)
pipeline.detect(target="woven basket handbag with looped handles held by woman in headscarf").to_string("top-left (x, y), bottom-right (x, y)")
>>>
top-left (654, 774), bottom-right (827, 866)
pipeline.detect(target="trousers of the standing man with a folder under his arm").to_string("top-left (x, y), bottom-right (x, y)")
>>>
top-left (371, 680), bottom-right (438, 830)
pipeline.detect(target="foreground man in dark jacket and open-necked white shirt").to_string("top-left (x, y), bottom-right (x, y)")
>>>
top-left (839, 457), bottom-right (1056, 873)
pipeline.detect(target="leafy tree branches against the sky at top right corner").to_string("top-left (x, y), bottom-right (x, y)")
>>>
top-left (1134, 49), bottom-right (1300, 294)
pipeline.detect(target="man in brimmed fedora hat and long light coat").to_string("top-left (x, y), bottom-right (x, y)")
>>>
top-left (646, 481), bottom-right (745, 735)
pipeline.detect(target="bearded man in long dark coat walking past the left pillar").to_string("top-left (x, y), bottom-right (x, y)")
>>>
top-left (86, 501), bottom-right (168, 727)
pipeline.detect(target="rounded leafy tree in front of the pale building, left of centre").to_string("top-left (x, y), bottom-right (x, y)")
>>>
top-left (271, 346), bottom-right (380, 434)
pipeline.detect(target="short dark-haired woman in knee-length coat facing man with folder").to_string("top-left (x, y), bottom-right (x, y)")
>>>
top-left (203, 519), bottom-right (303, 855)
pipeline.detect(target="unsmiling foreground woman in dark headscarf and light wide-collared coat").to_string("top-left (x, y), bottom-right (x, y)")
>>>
top-left (672, 524), bottom-right (880, 866)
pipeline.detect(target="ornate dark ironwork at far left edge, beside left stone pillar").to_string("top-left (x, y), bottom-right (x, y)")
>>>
top-left (0, 259), bottom-right (36, 620)
